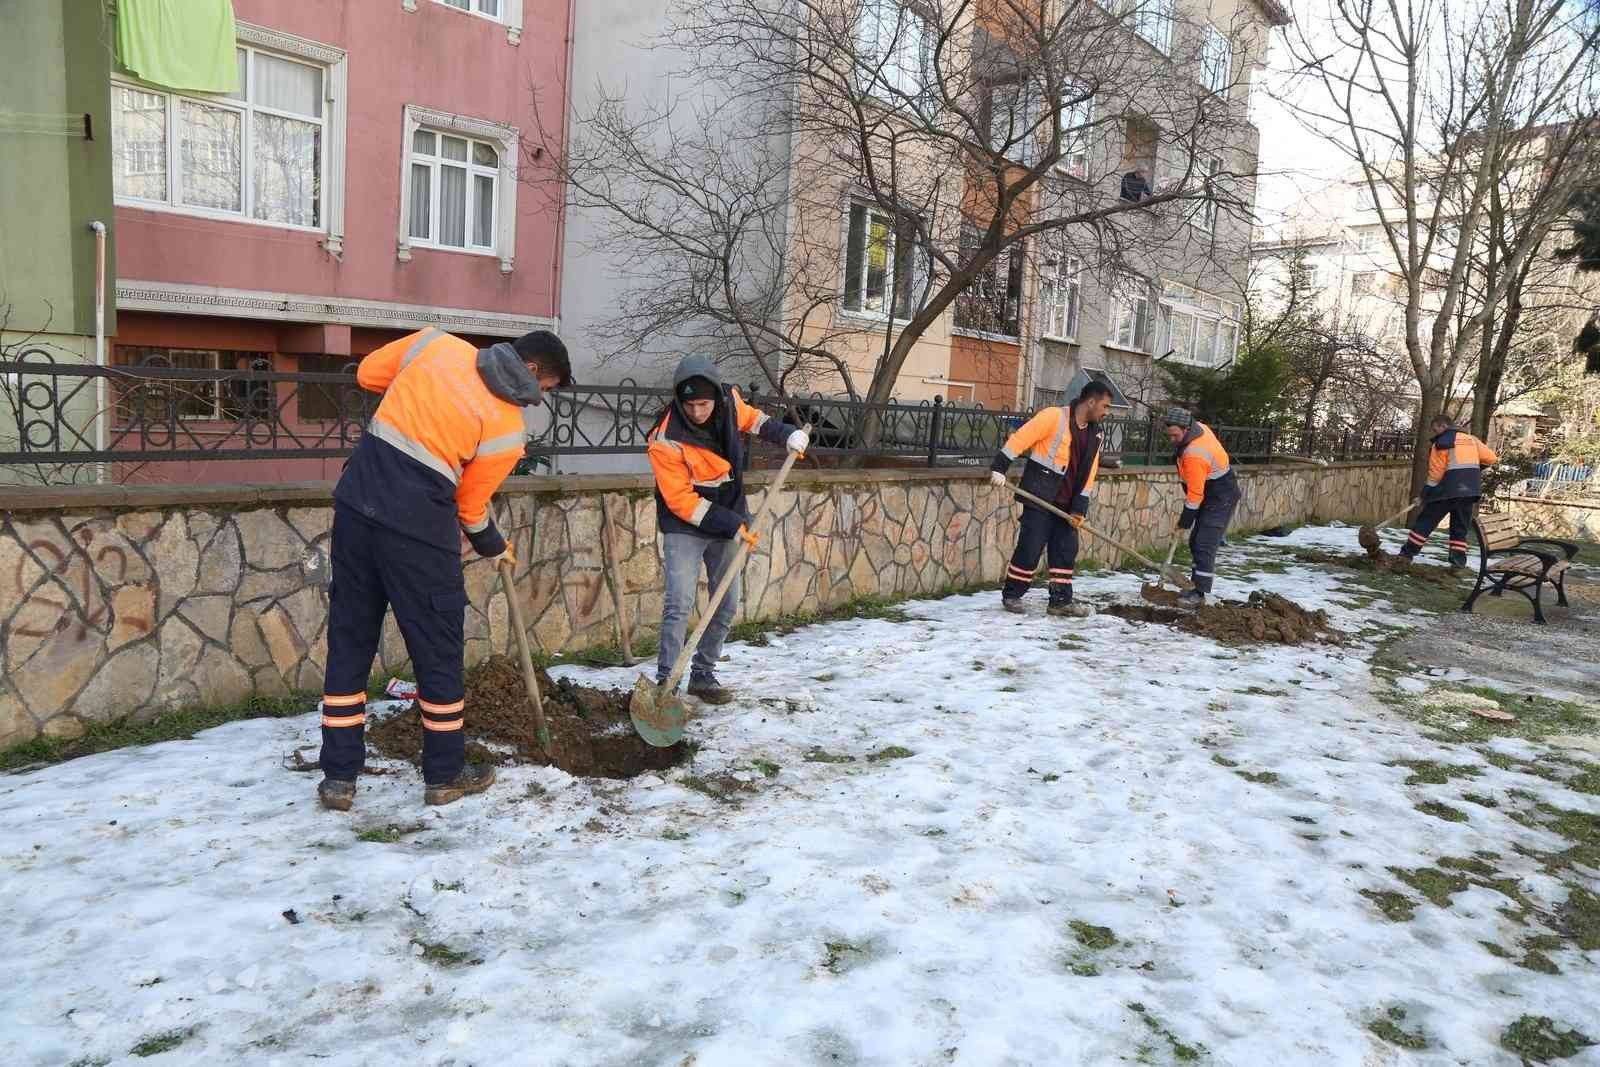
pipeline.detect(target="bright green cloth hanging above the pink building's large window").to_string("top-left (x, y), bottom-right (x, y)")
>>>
top-left (117, 0), bottom-right (238, 93)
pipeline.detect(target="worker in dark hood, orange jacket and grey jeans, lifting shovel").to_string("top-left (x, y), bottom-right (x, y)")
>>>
top-left (648, 355), bottom-right (808, 704)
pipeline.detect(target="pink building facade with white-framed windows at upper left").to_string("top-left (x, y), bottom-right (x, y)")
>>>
top-left (110, 0), bottom-right (571, 482)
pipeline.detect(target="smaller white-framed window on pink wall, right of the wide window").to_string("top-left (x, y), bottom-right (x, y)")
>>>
top-left (410, 130), bottom-right (499, 253)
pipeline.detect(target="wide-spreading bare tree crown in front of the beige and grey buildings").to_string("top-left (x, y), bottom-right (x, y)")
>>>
top-left (539, 0), bottom-right (1259, 422)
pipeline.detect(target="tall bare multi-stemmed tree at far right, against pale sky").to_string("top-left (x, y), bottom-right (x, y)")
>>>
top-left (1285, 0), bottom-right (1600, 488)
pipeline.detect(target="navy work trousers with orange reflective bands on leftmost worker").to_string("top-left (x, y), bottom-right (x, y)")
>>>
top-left (322, 506), bottom-right (467, 785)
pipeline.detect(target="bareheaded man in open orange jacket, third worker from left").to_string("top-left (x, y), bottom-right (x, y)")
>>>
top-left (989, 381), bottom-right (1112, 617)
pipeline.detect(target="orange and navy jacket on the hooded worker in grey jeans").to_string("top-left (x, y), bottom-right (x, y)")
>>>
top-left (648, 386), bottom-right (794, 537)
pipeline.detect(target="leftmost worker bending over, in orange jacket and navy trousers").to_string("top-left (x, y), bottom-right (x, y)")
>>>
top-left (317, 328), bottom-right (573, 811)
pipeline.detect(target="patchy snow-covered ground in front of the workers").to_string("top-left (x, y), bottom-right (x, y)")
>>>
top-left (0, 528), bottom-right (1600, 1067)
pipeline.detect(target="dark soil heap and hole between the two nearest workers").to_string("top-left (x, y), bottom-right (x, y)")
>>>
top-left (366, 656), bottom-right (690, 777)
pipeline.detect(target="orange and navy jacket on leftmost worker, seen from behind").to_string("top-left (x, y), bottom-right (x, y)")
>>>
top-left (334, 328), bottom-right (538, 555)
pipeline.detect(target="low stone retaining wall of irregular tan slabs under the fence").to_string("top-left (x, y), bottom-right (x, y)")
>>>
top-left (0, 464), bottom-right (1408, 747)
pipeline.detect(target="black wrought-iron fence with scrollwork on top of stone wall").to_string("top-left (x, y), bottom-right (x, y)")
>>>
top-left (0, 349), bottom-right (1410, 469)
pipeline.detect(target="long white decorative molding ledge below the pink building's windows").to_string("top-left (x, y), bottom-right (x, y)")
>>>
top-left (117, 278), bottom-right (560, 338)
